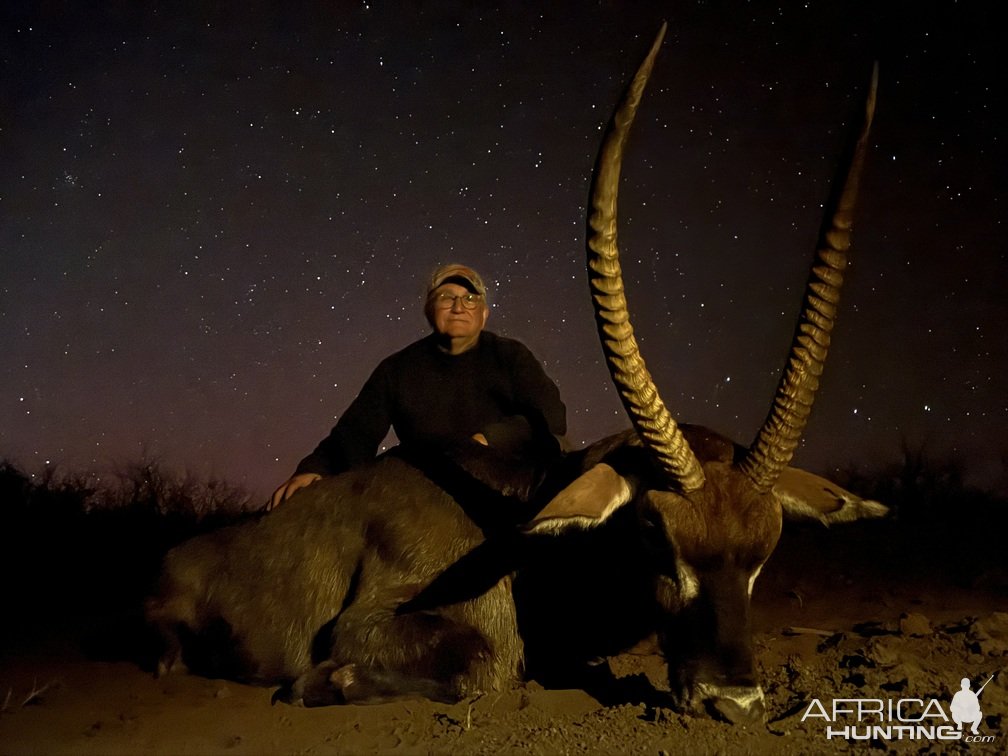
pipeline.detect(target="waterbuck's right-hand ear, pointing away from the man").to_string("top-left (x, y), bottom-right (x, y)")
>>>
top-left (773, 468), bottom-right (889, 525)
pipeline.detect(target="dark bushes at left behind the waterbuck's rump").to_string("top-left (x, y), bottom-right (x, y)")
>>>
top-left (0, 459), bottom-right (251, 657)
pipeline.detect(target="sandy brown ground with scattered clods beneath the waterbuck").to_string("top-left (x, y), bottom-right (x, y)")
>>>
top-left (0, 595), bottom-right (1008, 754)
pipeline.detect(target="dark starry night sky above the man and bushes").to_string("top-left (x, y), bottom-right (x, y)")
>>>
top-left (0, 0), bottom-right (1008, 498)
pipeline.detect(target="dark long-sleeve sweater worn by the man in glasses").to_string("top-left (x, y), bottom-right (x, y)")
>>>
top-left (296, 331), bottom-right (566, 475)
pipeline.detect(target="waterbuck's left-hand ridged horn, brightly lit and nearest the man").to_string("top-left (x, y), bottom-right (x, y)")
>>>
top-left (588, 23), bottom-right (704, 491)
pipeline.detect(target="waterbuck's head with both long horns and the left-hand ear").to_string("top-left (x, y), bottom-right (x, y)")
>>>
top-left (527, 26), bottom-right (877, 721)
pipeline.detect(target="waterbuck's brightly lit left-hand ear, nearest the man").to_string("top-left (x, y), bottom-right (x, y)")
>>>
top-left (522, 463), bottom-right (633, 533)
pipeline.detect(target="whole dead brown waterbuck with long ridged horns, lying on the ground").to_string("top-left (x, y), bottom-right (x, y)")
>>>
top-left (147, 26), bottom-right (885, 721)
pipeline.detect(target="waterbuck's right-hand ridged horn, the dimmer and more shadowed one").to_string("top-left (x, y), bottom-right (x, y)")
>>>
top-left (739, 64), bottom-right (878, 491)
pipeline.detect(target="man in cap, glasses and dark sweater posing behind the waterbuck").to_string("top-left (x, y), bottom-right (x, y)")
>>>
top-left (269, 263), bottom-right (566, 509)
